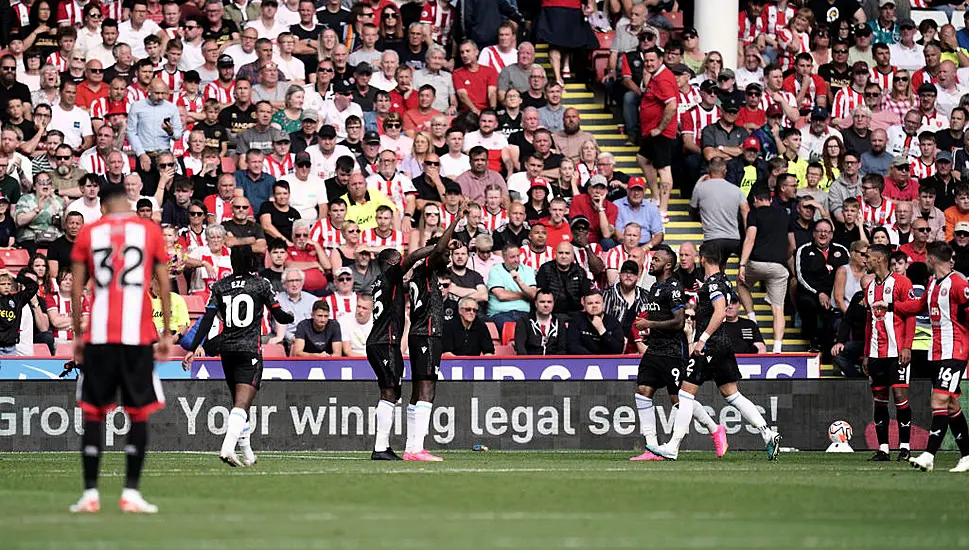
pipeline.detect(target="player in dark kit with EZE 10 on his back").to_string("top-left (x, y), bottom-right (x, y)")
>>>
top-left (182, 246), bottom-right (294, 467)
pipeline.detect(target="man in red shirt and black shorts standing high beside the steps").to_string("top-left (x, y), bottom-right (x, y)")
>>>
top-left (636, 47), bottom-right (680, 220)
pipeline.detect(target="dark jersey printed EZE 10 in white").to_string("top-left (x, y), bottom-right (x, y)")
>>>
top-left (207, 275), bottom-right (279, 353)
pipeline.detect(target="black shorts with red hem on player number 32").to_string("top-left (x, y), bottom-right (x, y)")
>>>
top-left (77, 344), bottom-right (165, 416)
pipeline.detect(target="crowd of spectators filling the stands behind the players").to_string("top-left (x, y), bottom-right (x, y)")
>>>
top-left (0, 0), bottom-right (969, 373)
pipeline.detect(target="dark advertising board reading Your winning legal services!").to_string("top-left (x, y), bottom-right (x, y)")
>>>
top-left (0, 380), bottom-right (931, 452)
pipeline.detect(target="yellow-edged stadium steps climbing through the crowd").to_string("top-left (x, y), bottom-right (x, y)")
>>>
top-left (535, 49), bottom-right (838, 376)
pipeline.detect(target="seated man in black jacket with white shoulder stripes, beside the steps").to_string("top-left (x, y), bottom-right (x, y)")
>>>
top-left (794, 220), bottom-right (848, 353)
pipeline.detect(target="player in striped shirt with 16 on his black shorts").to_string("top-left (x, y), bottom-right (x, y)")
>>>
top-left (896, 241), bottom-right (969, 472)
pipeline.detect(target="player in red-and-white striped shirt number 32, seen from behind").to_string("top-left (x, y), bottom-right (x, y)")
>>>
top-left (70, 186), bottom-right (171, 514)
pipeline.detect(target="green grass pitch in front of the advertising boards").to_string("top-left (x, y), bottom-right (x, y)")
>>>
top-left (0, 451), bottom-right (969, 550)
